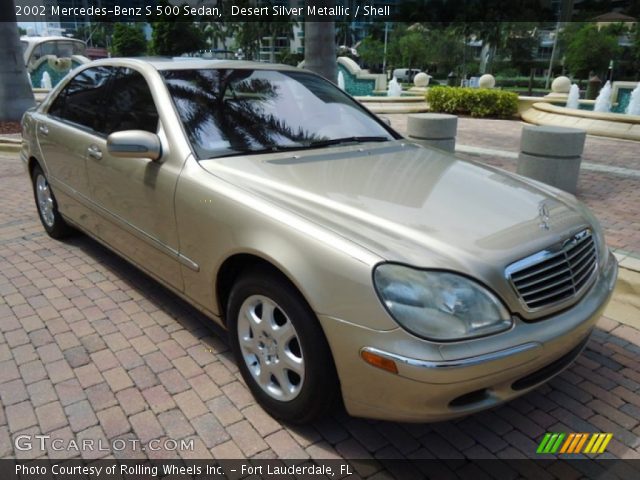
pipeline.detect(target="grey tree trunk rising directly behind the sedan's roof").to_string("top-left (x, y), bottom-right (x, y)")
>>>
top-left (304, 22), bottom-right (338, 83)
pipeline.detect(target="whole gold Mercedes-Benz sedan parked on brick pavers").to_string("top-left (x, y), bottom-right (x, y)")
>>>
top-left (21, 59), bottom-right (617, 422)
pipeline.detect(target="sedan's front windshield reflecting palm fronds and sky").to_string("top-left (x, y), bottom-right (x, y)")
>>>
top-left (163, 69), bottom-right (396, 159)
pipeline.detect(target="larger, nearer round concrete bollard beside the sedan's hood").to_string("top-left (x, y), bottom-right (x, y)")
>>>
top-left (517, 125), bottom-right (587, 193)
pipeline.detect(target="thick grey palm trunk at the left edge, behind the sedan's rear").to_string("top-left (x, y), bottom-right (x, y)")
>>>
top-left (0, 0), bottom-right (35, 122)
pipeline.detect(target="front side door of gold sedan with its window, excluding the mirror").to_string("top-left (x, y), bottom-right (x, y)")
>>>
top-left (87, 68), bottom-right (182, 290)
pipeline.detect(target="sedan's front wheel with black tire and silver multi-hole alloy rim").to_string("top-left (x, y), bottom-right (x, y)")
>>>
top-left (227, 269), bottom-right (338, 424)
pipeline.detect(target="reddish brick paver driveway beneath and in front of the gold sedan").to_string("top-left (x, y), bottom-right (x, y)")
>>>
top-left (0, 149), bottom-right (640, 476)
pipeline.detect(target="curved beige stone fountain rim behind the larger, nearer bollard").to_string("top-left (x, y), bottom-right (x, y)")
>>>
top-left (521, 102), bottom-right (640, 141)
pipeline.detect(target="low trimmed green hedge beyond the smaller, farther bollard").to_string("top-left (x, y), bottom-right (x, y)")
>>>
top-left (427, 87), bottom-right (518, 117)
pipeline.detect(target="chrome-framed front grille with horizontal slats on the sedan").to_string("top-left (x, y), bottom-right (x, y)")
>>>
top-left (507, 229), bottom-right (598, 311)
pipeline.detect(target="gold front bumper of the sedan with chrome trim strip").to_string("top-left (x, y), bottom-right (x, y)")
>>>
top-left (319, 255), bottom-right (618, 422)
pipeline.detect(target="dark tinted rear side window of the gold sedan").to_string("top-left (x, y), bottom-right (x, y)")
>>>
top-left (49, 67), bottom-right (114, 132)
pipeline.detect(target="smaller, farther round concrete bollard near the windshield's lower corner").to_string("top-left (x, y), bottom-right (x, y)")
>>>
top-left (407, 113), bottom-right (458, 152)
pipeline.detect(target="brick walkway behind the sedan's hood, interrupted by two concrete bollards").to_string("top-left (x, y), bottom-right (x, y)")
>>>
top-left (385, 115), bottom-right (640, 258)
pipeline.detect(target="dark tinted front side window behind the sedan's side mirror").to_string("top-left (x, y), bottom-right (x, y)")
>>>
top-left (104, 68), bottom-right (158, 135)
